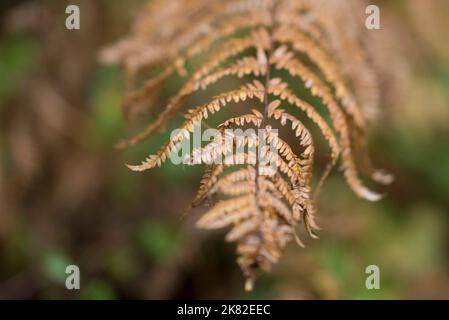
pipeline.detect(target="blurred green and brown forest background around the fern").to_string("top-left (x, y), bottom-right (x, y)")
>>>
top-left (0, 0), bottom-right (449, 299)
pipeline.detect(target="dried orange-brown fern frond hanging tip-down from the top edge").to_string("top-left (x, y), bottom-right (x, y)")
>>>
top-left (103, 0), bottom-right (391, 290)
